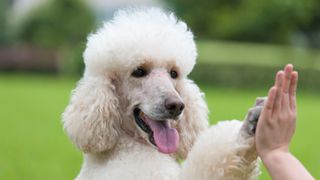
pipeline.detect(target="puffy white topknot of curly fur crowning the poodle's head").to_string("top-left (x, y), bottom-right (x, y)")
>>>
top-left (84, 8), bottom-right (197, 75)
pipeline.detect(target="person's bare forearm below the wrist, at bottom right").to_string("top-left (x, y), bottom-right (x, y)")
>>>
top-left (261, 151), bottom-right (314, 180)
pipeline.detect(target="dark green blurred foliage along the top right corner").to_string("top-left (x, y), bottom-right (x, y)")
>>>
top-left (167, 0), bottom-right (320, 47)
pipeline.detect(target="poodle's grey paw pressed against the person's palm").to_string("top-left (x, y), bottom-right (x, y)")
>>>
top-left (242, 97), bottom-right (267, 135)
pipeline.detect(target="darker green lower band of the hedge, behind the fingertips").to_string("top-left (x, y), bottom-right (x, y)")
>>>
top-left (190, 61), bottom-right (320, 91)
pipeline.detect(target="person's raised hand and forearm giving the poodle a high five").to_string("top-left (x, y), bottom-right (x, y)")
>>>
top-left (255, 64), bottom-right (314, 180)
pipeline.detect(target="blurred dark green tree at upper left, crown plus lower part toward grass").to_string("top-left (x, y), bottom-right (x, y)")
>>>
top-left (16, 0), bottom-right (95, 74)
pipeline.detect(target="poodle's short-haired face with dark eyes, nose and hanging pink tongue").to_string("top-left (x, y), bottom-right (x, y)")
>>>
top-left (115, 60), bottom-right (185, 153)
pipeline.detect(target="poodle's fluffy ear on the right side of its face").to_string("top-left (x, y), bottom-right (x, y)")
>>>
top-left (177, 79), bottom-right (208, 159)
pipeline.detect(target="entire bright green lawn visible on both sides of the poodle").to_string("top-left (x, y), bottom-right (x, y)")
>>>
top-left (0, 74), bottom-right (320, 180)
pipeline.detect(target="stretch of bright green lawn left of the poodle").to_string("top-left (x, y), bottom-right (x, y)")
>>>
top-left (0, 75), bottom-right (82, 180)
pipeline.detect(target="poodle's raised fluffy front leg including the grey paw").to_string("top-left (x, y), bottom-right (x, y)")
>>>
top-left (181, 99), bottom-right (264, 180)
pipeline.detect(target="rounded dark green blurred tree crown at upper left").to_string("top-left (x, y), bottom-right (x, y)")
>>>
top-left (18, 0), bottom-right (94, 47)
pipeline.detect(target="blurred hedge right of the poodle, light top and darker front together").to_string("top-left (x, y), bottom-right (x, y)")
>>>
top-left (190, 41), bottom-right (320, 92)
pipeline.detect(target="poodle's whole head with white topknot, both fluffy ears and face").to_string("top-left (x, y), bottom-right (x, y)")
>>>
top-left (63, 8), bottom-right (207, 157)
